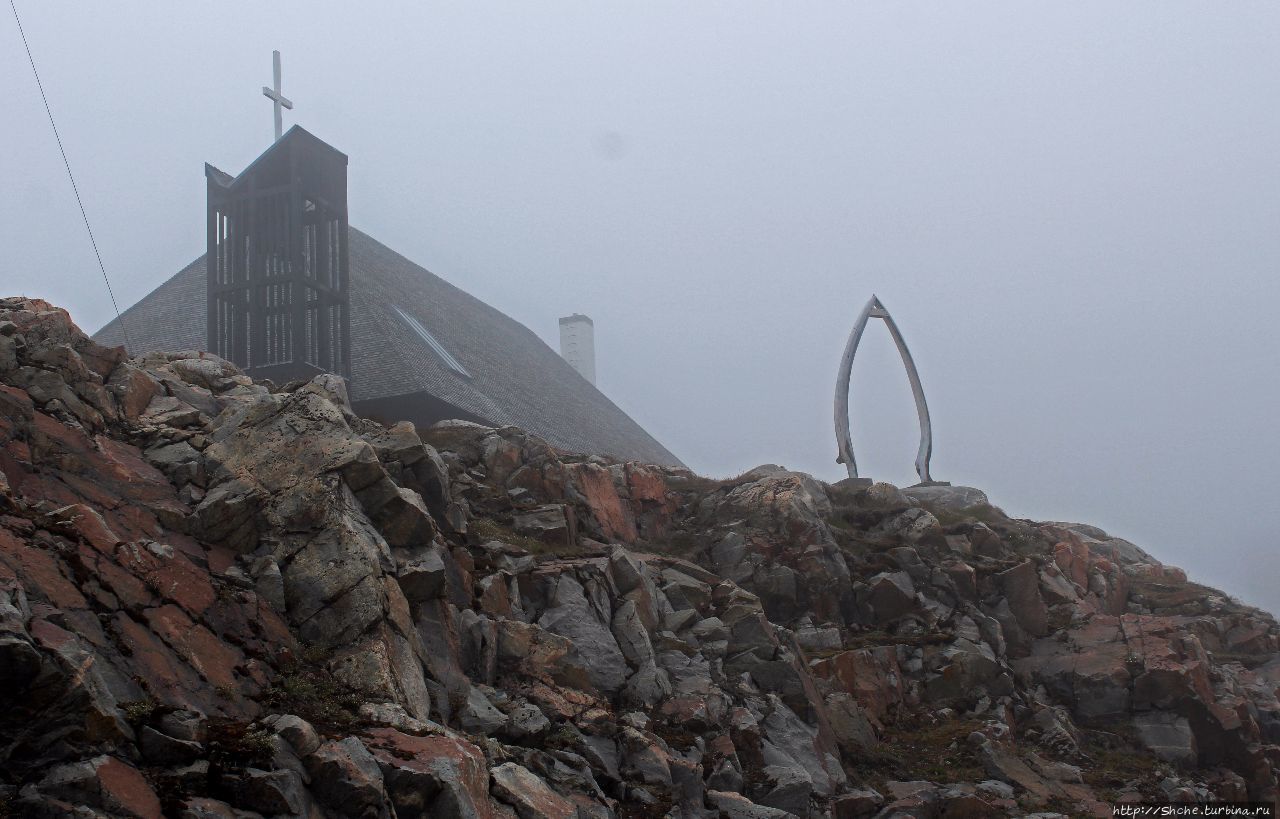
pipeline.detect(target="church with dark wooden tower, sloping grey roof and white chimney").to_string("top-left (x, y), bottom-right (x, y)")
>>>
top-left (93, 122), bottom-right (681, 466)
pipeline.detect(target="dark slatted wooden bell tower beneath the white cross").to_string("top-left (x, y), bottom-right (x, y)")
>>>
top-left (205, 125), bottom-right (351, 383)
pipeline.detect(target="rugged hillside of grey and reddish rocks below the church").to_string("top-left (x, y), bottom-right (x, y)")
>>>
top-left (0, 298), bottom-right (1280, 819)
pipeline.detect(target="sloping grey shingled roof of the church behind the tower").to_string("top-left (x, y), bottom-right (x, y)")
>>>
top-left (93, 228), bottom-right (681, 466)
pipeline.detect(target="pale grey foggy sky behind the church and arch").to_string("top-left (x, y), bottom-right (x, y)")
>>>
top-left (0, 0), bottom-right (1280, 610)
